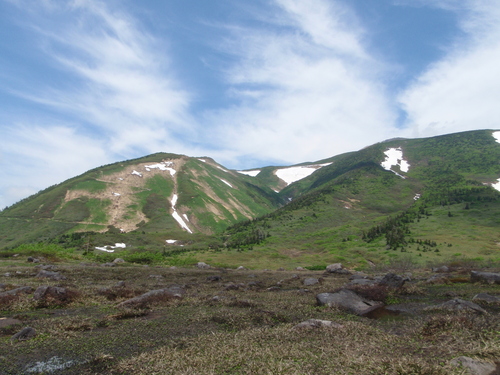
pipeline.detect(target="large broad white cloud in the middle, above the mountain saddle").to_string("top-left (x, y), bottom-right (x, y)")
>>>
top-left (205, 0), bottom-right (394, 166)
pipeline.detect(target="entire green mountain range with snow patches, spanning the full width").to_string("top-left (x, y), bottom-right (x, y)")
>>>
top-left (0, 130), bottom-right (500, 263)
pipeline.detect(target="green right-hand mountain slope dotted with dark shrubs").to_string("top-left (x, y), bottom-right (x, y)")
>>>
top-left (220, 131), bottom-right (500, 264)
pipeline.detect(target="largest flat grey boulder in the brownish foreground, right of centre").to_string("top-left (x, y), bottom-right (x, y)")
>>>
top-left (316, 289), bottom-right (384, 315)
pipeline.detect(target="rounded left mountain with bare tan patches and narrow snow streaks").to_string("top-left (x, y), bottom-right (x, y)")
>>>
top-left (0, 153), bottom-right (281, 247)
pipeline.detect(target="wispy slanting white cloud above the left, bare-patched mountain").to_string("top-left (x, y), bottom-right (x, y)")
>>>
top-left (4, 0), bottom-right (190, 154)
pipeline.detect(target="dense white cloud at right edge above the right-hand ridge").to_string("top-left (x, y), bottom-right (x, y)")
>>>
top-left (400, 0), bottom-right (500, 137)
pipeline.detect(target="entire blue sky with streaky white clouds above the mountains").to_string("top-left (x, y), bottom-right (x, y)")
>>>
top-left (0, 0), bottom-right (500, 207)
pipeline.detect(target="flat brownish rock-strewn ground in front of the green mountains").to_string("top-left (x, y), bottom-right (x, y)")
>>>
top-left (0, 261), bottom-right (500, 374)
